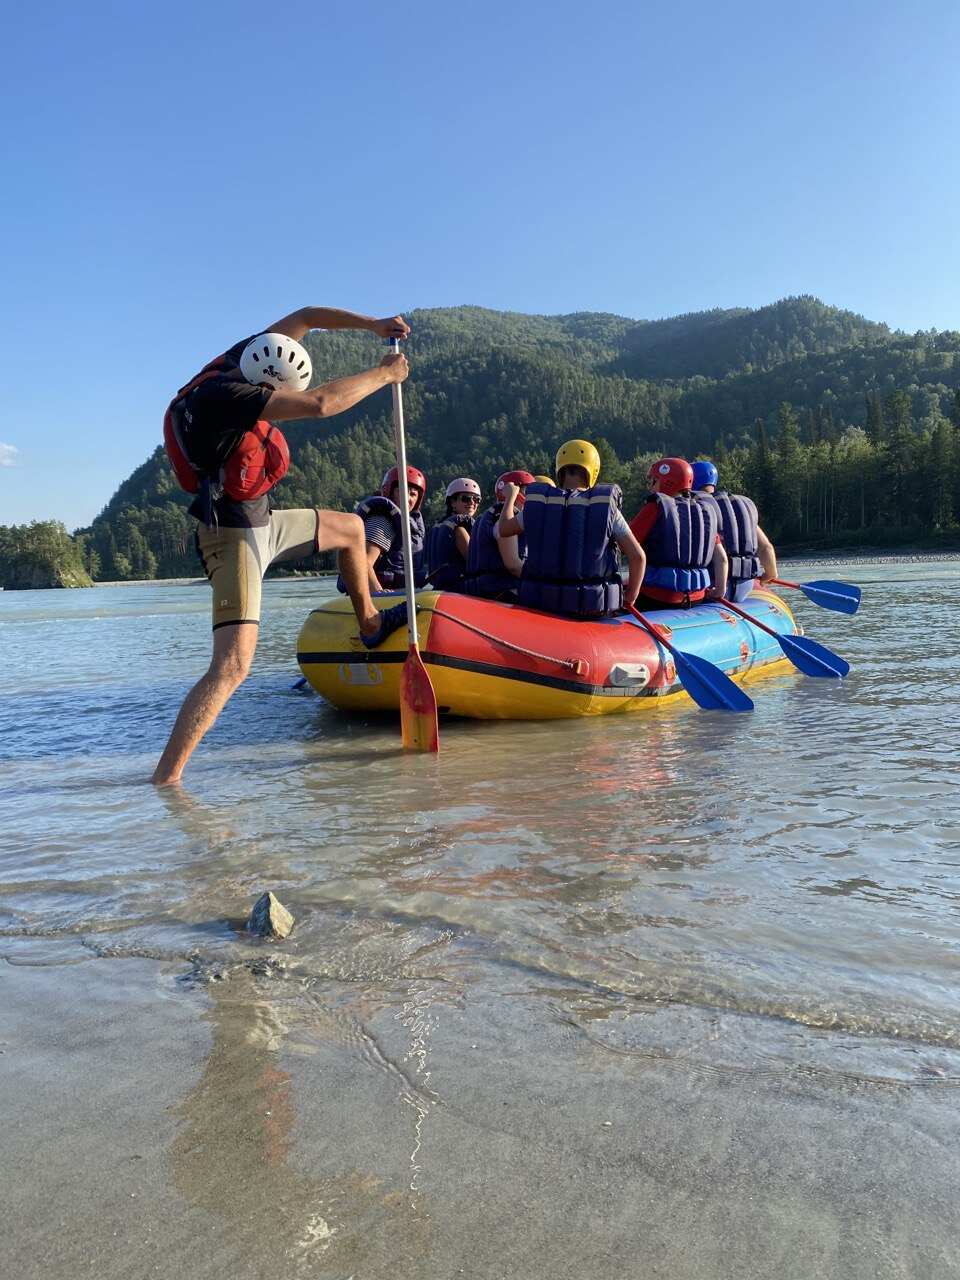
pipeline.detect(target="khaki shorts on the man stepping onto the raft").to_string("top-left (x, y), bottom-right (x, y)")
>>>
top-left (197, 507), bottom-right (320, 631)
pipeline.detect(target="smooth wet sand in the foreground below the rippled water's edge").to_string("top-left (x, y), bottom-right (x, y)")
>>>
top-left (0, 940), bottom-right (960, 1280)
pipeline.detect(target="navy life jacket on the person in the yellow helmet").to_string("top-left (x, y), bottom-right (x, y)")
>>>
top-left (518, 484), bottom-right (623, 618)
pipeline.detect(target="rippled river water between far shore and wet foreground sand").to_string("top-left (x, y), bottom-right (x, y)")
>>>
top-left (0, 562), bottom-right (960, 1074)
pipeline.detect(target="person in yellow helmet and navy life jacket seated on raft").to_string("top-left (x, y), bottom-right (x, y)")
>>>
top-left (499, 440), bottom-right (645, 618)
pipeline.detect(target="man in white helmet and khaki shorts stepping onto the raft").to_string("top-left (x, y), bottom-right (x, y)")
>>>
top-left (152, 307), bottom-right (410, 786)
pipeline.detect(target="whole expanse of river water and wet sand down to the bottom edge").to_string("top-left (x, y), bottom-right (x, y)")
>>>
top-left (0, 561), bottom-right (960, 1280)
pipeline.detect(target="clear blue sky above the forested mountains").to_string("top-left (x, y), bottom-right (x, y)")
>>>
top-left (0, 0), bottom-right (960, 527)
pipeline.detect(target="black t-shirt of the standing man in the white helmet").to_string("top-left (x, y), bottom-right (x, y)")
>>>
top-left (173, 335), bottom-right (273, 529)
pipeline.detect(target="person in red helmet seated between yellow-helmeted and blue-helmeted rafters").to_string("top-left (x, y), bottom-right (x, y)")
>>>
top-left (630, 458), bottom-right (727, 609)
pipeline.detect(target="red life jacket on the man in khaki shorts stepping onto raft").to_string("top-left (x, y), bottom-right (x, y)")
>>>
top-left (164, 353), bottom-right (291, 502)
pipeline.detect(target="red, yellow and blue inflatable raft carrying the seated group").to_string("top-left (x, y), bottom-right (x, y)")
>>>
top-left (297, 590), bottom-right (801, 719)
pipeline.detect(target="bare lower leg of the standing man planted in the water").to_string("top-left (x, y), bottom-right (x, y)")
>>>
top-left (151, 624), bottom-right (257, 787)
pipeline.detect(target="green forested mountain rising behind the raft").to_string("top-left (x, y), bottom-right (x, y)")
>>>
top-left (62, 297), bottom-right (960, 579)
